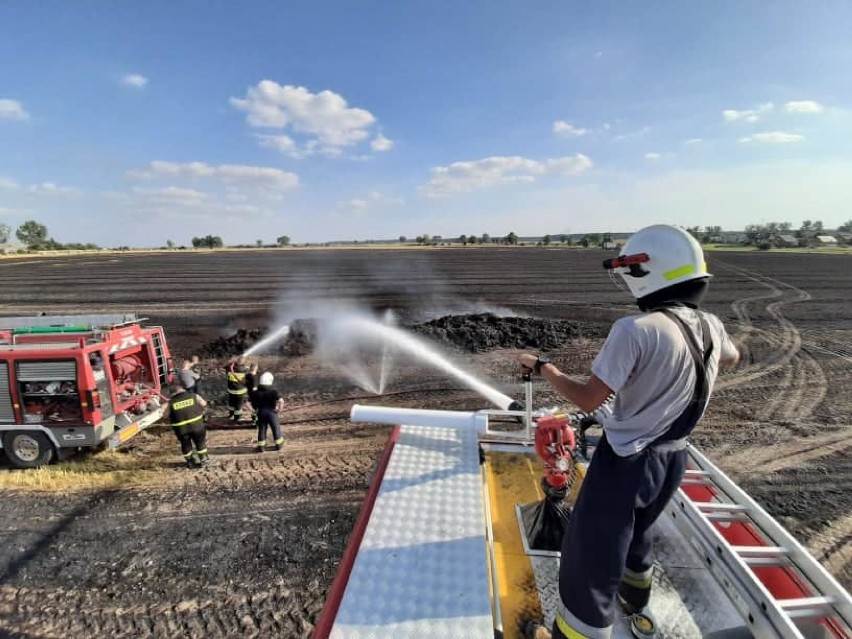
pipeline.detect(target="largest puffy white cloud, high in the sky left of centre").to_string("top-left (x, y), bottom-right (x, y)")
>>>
top-left (230, 80), bottom-right (382, 157)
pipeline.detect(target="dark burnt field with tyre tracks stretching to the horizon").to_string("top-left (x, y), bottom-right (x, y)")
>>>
top-left (0, 247), bottom-right (852, 638)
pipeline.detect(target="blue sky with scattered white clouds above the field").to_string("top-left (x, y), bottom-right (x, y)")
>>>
top-left (0, 0), bottom-right (852, 246)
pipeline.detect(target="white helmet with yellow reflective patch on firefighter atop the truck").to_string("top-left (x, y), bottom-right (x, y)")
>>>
top-left (604, 224), bottom-right (712, 299)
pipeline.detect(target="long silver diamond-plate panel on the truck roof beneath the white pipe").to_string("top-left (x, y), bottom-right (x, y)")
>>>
top-left (329, 426), bottom-right (494, 639)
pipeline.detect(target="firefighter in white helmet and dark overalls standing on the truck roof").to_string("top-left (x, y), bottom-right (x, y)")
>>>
top-left (519, 225), bottom-right (739, 639)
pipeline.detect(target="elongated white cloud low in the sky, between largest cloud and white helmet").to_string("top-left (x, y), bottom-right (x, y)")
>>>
top-left (418, 154), bottom-right (592, 197)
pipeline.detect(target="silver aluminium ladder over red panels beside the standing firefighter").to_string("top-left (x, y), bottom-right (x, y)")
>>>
top-left (667, 446), bottom-right (852, 639)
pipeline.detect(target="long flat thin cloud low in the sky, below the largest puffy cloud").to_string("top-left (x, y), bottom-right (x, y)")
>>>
top-left (127, 160), bottom-right (299, 190)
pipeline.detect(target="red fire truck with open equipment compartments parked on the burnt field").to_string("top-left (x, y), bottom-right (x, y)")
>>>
top-left (0, 314), bottom-right (173, 468)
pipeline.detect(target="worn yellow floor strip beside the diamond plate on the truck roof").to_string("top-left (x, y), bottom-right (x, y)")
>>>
top-left (484, 451), bottom-right (544, 639)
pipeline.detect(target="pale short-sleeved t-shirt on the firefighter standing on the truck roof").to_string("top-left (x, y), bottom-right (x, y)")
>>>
top-left (592, 306), bottom-right (737, 457)
